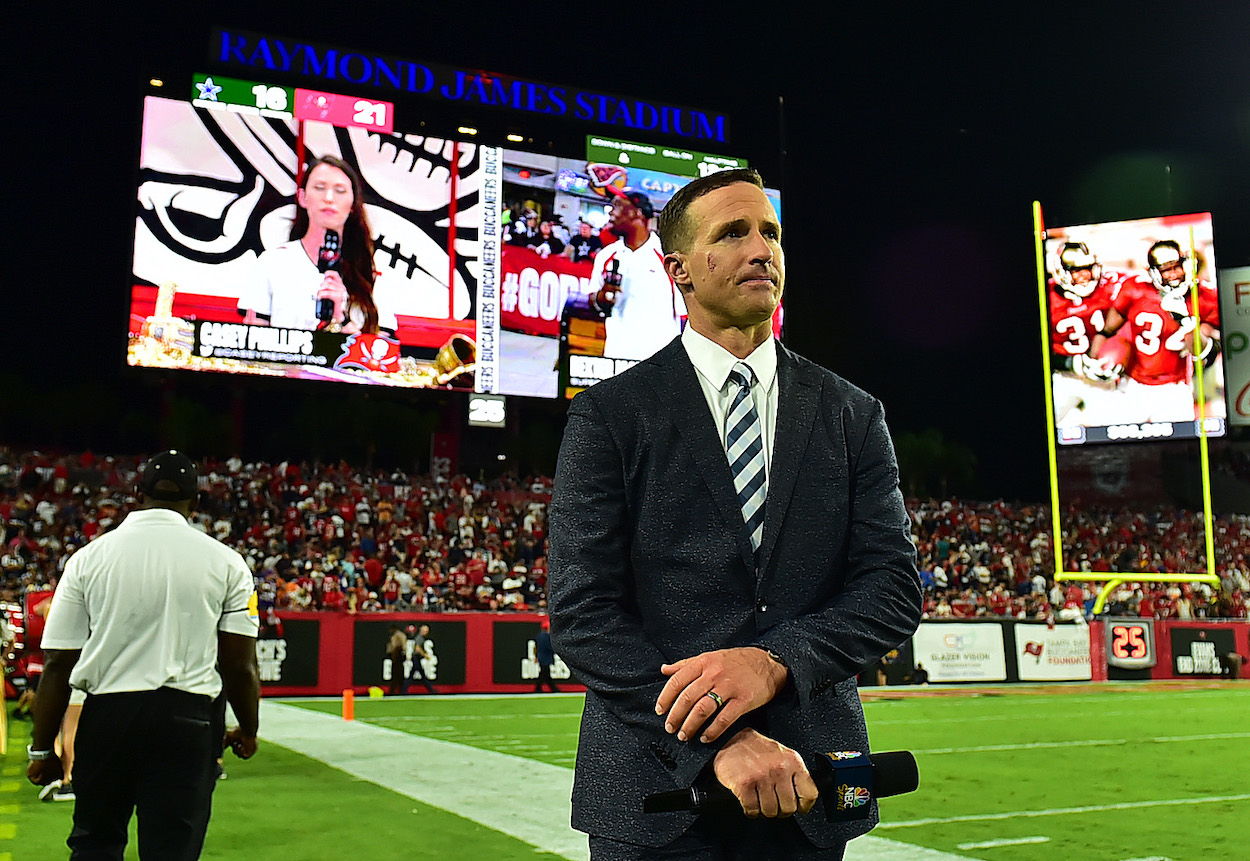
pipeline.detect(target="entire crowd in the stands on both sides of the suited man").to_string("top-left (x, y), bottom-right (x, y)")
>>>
top-left (0, 447), bottom-right (1250, 624)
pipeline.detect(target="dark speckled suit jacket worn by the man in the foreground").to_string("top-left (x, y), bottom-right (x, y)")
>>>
top-left (549, 339), bottom-right (920, 846)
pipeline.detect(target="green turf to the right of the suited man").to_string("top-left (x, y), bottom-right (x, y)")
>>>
top-left (865, 685), bottom-right (1250, 861)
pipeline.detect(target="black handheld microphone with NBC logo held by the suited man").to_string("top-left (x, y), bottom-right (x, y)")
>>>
top-left (643, 750), bottom-right (920, 822)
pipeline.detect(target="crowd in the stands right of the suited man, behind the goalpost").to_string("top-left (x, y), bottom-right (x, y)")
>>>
top-left (908, 500), bottom-right (1250, 621)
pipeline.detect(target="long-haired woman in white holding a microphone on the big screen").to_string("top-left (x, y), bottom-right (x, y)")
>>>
top-left (239, 155), bottom-right (398, 335)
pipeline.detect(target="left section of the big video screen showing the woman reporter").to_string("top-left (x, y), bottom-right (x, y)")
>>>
top-left (129, 90), bottom-right (481, 389)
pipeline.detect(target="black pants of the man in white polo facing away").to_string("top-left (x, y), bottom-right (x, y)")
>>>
top-left (65, 687), bottom-right (220, 861)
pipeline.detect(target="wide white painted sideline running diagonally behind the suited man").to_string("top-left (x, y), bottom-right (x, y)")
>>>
top-left (260, 700), bottom-right (965, 861)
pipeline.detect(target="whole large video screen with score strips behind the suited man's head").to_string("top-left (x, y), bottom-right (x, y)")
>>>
top-left (128, 75), bottom-right (780, 397)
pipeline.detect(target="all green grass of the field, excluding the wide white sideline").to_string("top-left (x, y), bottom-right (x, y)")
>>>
top-left (0, 685), bottom-right (1250, 861)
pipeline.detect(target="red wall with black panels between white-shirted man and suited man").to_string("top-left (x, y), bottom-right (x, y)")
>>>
top-left (258, 612), bottom-right (585, 696)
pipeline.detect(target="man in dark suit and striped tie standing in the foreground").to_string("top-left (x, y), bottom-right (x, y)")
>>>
top-left (550, 170), bottom-right (920, 861)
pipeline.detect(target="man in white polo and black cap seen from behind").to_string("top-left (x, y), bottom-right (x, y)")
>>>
top-left (26, 451), bottom-right (260, 859)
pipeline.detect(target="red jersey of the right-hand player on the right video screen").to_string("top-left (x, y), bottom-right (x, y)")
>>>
top-left (1114, 279), bottom-right (1220, 386)
